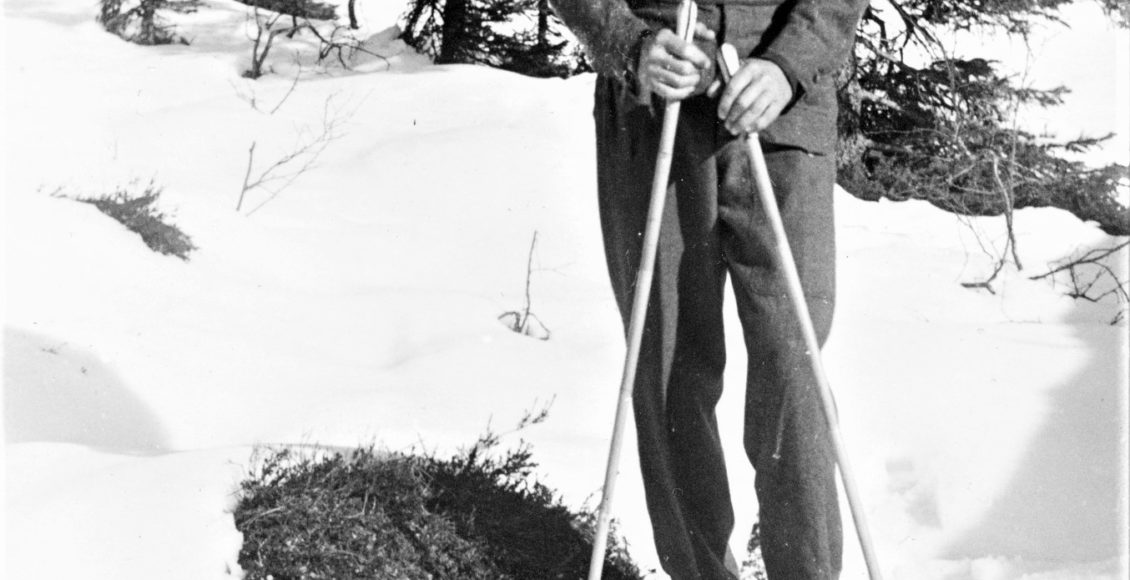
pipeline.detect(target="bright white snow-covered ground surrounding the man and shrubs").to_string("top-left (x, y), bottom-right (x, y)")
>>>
top-left (2, 0), bottom-right (1128, 580)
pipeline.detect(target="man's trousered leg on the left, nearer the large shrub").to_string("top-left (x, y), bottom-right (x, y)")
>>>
top-left (596, 80), bottom-right (733, 580)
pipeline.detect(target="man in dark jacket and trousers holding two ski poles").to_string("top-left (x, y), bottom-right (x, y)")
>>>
top-left (555, 0), bottom-right (867, 580)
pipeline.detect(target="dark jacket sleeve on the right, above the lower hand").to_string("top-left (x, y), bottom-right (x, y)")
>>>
top-left (758, 0), bottom-right (869, 92)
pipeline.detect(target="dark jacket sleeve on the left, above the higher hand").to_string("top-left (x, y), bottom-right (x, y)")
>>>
top-left (550, 0), bottom-right (650, 80)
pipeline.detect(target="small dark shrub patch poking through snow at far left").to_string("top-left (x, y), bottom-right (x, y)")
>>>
top-left (76, 181), bottom-right (197, 261)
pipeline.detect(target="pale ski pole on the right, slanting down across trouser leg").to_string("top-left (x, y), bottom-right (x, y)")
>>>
top-left (718, 44), bottom-right (883, 580)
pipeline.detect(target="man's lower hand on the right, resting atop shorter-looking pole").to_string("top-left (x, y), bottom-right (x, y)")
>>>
top-left (718, 59), bottom-right (792, 135)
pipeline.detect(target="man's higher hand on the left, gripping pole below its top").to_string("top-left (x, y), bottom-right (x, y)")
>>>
top-left (636, 23), bottom-right (714, 101)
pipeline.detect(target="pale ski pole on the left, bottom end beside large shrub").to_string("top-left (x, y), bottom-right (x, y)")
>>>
top-left (589, 0), bottom-right (697, 580)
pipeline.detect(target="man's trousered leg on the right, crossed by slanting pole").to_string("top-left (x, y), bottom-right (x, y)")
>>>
top-left (719, 141), bottom-right (842, 580)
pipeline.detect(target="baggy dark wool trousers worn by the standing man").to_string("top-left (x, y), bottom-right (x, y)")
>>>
top-left (594, 78), bottom-right (842, 580)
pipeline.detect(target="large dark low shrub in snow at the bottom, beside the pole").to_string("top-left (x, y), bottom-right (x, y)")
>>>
top-left (235, 434), bottom-right (641, 580)
